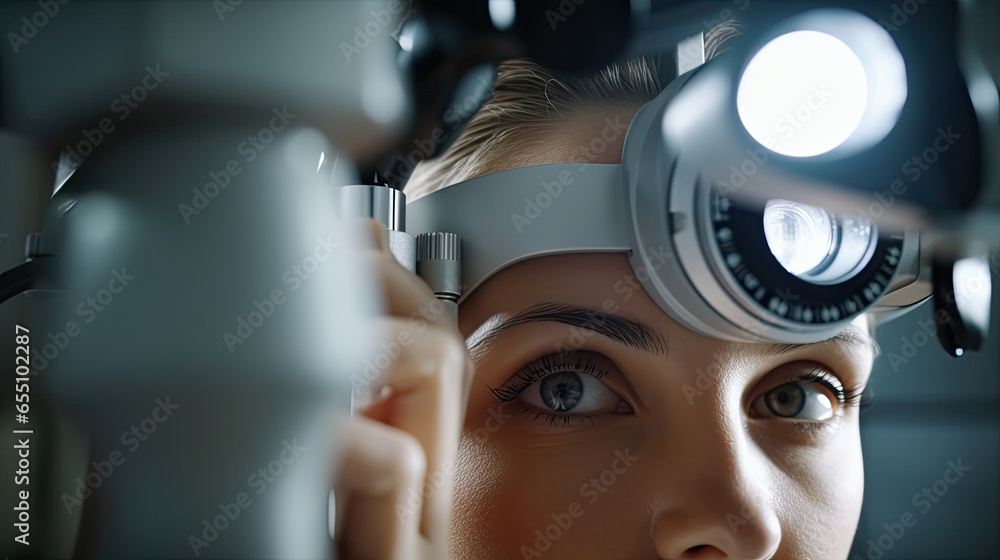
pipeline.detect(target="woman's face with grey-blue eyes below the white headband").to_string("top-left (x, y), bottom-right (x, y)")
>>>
top-left (452, 111), bottom-right (873, 560)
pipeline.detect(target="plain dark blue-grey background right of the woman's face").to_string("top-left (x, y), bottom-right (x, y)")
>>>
top-left (850, 270), bottom-right (1000, 560)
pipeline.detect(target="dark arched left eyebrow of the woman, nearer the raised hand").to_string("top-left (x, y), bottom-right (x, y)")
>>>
top-left (469, 302), bottom-right (667, 356)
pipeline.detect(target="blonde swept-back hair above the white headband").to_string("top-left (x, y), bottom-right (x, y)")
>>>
top-left (405, 20), bottom-right (741, 200)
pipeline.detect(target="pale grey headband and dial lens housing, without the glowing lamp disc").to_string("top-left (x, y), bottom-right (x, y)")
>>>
top-left (407, 6), bottom-right (931, 344)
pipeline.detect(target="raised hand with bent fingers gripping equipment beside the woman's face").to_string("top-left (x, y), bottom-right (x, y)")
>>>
top-left (334, 220), bottom-right (473, 560)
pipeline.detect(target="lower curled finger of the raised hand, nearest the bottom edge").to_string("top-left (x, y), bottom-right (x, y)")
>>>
top-left (335, 418), bottom-right (426, 560)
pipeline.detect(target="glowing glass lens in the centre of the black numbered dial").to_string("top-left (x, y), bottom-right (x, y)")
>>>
top-left (764, 199), bottom-right (877, 284)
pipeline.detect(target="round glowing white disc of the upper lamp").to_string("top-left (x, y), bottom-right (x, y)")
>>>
top-left (736, 31), bottom-right (868, 157)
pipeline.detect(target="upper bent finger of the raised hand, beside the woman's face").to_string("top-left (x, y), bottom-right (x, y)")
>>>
top-left (356, 317), bottom-right (472, 546)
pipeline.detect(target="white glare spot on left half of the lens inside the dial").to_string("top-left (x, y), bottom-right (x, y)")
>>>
top-left (764, 199), bottom-right (837, 276)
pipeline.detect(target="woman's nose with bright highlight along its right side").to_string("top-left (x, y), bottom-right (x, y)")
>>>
top-left (652, 382), bottom-right (781, 559)
